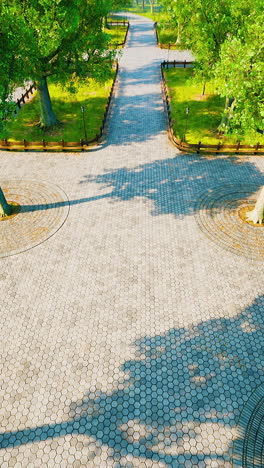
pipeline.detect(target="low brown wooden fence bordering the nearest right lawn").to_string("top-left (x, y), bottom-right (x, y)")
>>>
top-left (161, 61), bottom-right (264, 154)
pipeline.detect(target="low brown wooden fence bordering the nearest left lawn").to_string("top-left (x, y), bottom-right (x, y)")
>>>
top-left (0, 62), bottom-right (119, 151)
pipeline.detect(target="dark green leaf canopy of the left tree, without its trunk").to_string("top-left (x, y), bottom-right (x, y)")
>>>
top-left (0, 0), bottom-right (113, 126)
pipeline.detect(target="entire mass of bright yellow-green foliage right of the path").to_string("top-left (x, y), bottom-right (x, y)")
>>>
top-left (161, 0), bottom-right (264, 135)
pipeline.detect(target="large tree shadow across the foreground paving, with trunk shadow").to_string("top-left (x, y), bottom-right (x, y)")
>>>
top-left (0, 296), bottom-right (264, 468)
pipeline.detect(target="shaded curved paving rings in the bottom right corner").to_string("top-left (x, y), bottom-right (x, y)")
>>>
top-left (233, 384), bottom-right (264, 468)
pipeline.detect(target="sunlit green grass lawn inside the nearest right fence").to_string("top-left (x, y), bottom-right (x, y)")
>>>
top-left (164, 68), bottom-right (264, 144)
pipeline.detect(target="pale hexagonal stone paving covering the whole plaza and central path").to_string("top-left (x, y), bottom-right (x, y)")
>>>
top-left (0, 12), bottom-right (264, 468)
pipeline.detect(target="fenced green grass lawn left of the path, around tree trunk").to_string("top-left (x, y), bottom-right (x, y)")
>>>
top-left (0, 71), bottom-right (114, 141)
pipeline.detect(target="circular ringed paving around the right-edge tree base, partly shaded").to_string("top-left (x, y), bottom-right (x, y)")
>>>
top-left (195, 184), bottom-right (264, 261)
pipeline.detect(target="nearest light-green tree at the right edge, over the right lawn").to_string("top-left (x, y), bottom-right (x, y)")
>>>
top-left (214, 1), bottom-right (264, 133)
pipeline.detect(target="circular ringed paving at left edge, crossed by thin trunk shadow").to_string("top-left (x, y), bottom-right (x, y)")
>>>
top-left (0, 180), bottom-right (69, 257)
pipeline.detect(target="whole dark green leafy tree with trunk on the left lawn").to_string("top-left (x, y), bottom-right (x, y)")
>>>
top-left (3, 0), bottom-right (112, 128)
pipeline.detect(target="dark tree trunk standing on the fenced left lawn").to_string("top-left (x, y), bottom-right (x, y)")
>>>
top-left (37, 77), bottom-right (60, 128)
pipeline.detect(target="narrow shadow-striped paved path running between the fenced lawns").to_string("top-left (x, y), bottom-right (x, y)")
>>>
top-left (104, 14), bottom-right (192, 151)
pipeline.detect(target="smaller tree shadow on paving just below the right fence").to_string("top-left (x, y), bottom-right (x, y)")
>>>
top-left (81, 155), bottom-right (264, 217)
